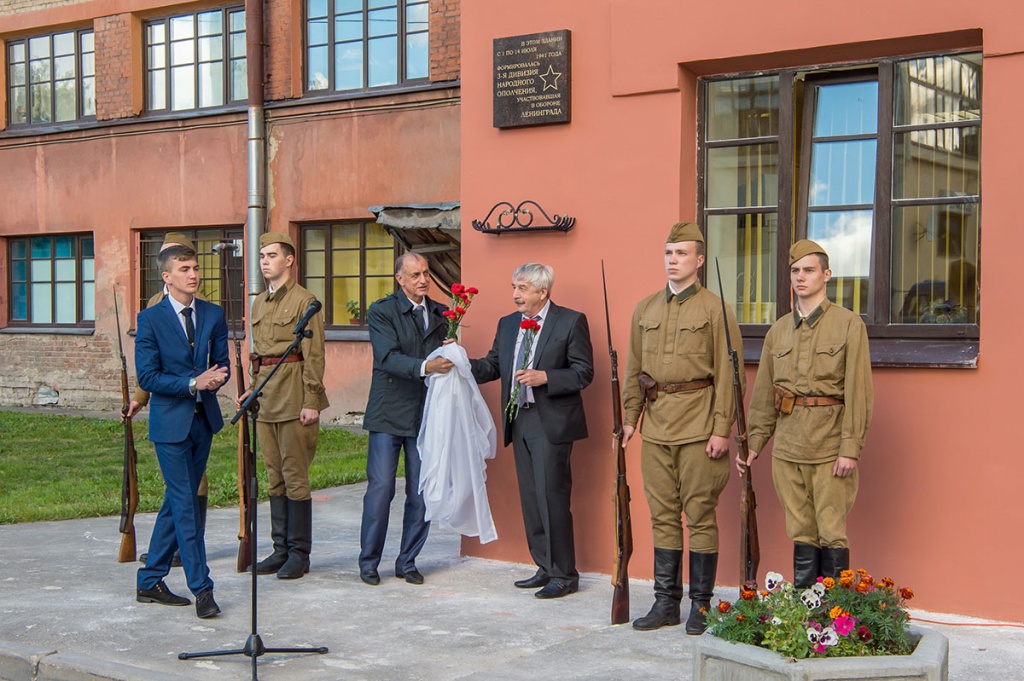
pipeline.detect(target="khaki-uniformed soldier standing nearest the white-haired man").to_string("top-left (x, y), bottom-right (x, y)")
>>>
top-left (623, 222), bottom-right (743, 634)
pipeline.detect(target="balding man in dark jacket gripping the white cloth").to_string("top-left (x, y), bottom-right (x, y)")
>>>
top-left (359, 253), bottom-right (453, 585)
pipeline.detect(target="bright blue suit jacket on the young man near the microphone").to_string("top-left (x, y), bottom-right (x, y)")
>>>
top-left (135, 298), bottom-right (230, 442)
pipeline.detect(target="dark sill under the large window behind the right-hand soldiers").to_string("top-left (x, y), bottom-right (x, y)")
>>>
top-left (743, 338), bottom-right (980, 369)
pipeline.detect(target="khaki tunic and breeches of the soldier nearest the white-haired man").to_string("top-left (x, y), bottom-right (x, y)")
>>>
top-left (623, 283), bottom-right (744, 553)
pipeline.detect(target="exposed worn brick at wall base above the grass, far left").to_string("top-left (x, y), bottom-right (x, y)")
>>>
top-left (0, 334), bottom-right (121, 410)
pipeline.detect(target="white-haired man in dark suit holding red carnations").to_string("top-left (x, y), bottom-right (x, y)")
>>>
top-left (471, 262), bottom-right (594, 598)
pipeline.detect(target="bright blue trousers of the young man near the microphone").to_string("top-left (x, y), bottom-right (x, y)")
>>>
top-left (136, 414), bottom-right (213, 594)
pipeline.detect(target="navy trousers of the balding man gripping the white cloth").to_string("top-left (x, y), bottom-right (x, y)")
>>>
top-left (359, 432), bottom-right (430, 573)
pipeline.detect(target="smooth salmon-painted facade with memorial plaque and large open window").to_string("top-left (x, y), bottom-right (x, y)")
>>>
top-left (462, 0), bottom-right (1024, 622)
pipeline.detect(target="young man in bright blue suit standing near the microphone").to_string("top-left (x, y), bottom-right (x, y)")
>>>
top-left (135, 246), bottom-right (228, 619)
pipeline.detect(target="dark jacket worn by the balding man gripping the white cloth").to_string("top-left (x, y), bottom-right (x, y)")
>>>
top-left (362, 290), bottom-right (447, 437)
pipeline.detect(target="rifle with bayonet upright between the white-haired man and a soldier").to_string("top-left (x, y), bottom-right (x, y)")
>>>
top-left (601, 260), bottom-right (633, 625)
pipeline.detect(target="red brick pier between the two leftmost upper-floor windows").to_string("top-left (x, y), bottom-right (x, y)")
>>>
top-left (93, 14), bottom-right (142, 121)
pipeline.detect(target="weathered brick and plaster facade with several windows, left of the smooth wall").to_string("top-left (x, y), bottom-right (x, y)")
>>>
top-left (0, 0), bottom-right (460, 422)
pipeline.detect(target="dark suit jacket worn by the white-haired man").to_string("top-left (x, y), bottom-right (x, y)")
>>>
top-left (471, 303), bottom-right (594, 445)
